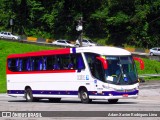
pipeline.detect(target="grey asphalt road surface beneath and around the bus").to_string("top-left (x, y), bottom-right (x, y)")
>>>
top-left (0, 81), bottom-right (160, 120)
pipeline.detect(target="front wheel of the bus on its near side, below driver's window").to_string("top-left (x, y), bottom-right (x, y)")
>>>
top-left (80, 89), bottom-right (92, 103)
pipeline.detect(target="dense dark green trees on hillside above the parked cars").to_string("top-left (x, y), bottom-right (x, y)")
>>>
top-left (0, 0), bottom-right (160, 48)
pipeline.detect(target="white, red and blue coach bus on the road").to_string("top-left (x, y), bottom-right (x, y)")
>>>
top-left (6, 46), bottom-right (144, 103)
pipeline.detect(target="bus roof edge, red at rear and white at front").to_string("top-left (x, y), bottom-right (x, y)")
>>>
top-left (8, 46), bottom-right (131, 58)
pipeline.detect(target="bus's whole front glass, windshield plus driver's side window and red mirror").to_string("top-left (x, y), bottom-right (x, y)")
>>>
top-left (85, 53), bottom-right (138, 85)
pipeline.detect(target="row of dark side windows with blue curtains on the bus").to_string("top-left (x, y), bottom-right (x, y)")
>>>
top-left (7, 54), bottom-right (85, 72)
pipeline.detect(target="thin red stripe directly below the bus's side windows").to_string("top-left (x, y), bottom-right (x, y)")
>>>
top-left (7, 70), bottom-right (76, 74)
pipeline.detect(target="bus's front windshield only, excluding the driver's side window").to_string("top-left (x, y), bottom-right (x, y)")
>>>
top-left (105, 56), bottom-right (138, 85)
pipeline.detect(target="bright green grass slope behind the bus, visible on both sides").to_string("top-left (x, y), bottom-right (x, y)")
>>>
top-left (0, 40), bottom-right (160, 93)
